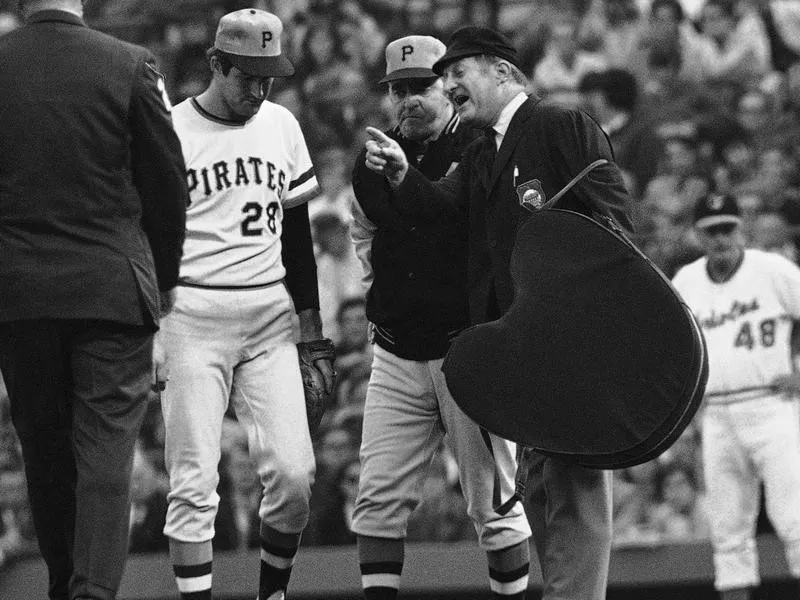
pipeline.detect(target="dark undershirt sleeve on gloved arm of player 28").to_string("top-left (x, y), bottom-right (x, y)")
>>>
top-left (281, 202), bottom-right (319, 312)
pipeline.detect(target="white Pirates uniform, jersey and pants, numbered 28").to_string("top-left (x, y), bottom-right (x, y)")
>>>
top-left (158, 99), bottom-right (318, 542)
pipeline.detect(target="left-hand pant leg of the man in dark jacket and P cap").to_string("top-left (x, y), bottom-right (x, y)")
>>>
top-left (352, 345), bottom-right (444, 538)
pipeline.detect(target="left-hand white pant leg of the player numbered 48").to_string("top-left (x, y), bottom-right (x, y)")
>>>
top-left (702, 404), bottom-right (760, 590)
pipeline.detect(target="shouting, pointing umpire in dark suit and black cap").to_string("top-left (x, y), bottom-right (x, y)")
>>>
top-left (366, 27), bottom-right (630, 600)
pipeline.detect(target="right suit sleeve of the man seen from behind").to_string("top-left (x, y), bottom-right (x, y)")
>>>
top-left (130, 53), bottom-right (189, 291)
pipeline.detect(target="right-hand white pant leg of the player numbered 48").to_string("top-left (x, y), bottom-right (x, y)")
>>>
top-left (742, 396), bottom-right (800, 578)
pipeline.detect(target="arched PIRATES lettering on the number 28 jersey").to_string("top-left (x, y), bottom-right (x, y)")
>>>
top-left (186, 156), bottom-right (286, 198)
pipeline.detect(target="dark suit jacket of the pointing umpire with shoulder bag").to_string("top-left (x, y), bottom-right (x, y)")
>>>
top-left (394, 97), bottom-right (631, 324)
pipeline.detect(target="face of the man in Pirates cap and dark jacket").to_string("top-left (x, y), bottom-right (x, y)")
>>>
top-left (389, 78), bottom-right (450, 141)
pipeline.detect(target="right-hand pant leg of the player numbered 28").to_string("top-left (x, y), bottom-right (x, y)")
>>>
top-left (231, 285), bottom-right (315, 533)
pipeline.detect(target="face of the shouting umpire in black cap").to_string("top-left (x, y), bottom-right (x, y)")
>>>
top-left (443, 56), bottom-right (504, 127)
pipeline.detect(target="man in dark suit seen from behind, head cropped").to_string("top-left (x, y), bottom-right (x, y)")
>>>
top-left (0, 0), bottom-right (188, 600)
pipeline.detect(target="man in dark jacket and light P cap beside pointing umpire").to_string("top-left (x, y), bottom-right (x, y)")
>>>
top-left (351, 35), bottom-right (531, 600)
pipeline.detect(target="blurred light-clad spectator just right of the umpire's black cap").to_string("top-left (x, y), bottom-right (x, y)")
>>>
top-left (532, 12), bottom-right (607, 96)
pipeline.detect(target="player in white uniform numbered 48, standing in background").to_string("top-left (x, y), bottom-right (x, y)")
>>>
top-left (673, 195), bottom-right (800, 600)
